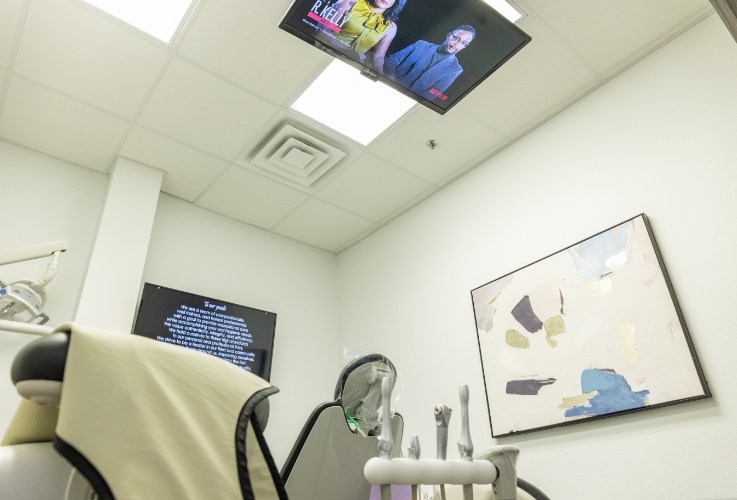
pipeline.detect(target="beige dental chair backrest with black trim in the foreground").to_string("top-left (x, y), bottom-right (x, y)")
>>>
top-left (4, 323), bottom-right (286, 500)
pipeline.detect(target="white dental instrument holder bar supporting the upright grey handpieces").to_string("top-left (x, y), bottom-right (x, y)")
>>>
top-left (363, 382), bottom-right (519, 500)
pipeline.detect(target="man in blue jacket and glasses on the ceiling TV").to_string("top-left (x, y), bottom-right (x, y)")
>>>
top-left (384, 24), bottom-right (476, 101)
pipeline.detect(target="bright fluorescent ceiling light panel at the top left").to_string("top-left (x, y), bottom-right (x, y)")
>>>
top-left (84, 0), bottom-right (194, 43)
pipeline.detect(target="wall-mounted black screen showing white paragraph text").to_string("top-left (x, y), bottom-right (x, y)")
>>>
top-left (133, 283), bottom-right (276, 380)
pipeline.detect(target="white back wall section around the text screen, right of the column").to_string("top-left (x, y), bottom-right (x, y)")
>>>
top-left (143, 196), bottom-right (343, 466)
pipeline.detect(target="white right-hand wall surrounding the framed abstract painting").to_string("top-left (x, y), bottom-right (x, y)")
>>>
top-left (338, 15), bottom-right (737, 500)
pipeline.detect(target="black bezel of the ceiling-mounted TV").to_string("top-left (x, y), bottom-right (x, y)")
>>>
top-left (279, 0), bottom-right (532, 115)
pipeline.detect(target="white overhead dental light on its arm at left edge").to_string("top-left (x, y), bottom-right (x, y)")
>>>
top-left (0, 241), bottom-right (67, 325)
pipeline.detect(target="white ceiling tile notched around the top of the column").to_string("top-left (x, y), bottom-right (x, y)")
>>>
top-left (120, 127), bottom-right (227, 201)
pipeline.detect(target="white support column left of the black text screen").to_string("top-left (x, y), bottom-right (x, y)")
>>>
top-left (74, 158), bottom-right (164, 332)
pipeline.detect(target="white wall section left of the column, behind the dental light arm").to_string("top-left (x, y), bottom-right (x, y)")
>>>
top-left (0, 142), bottom-right (107, 432)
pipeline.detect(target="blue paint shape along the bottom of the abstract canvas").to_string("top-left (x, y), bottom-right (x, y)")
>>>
top-left (565, 368), bottom-right (650, 417)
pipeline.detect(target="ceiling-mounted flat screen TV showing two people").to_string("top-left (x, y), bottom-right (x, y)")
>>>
top-left (279, 0), bottom-right (531, 114)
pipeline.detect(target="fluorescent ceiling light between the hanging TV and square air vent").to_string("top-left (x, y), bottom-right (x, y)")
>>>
top-left (292, 59), bottom-right (415, 146)
